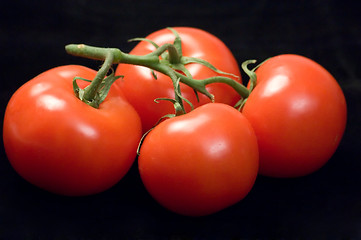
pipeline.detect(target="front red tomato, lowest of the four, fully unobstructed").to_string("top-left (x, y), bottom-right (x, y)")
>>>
top-left (138, 103), bottom-right (258, 216)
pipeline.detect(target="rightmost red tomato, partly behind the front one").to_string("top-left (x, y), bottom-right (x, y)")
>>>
top-left (243, 54), bottom-right (346, 177)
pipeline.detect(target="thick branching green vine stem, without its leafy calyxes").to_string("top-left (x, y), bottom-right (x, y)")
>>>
top-left (65, 44), bottom-right (249, 109)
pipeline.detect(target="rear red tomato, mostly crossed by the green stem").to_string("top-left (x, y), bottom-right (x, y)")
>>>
top-left (116, 27), bottom-right (240, 132)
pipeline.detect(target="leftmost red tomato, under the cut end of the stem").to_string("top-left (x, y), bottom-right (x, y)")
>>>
top-left (3, 65), bottom-right (141, 196)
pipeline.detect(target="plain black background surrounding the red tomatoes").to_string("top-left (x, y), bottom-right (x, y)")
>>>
top-left (0, 0), bottom-right (361, 239)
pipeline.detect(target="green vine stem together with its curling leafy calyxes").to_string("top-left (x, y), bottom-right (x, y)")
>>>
top-left (65, 28), bottom-right (249, 110)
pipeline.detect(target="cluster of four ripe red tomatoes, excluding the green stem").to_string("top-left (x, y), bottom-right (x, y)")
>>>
top-left (3, 27), bottom-right (346, 216)
